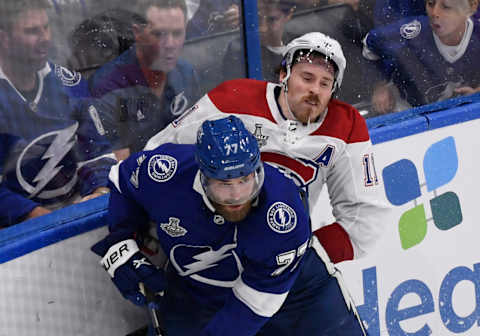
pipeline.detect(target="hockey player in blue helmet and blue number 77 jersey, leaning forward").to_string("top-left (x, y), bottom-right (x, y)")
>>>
top-left (92, 116), bottom-right (364, 336)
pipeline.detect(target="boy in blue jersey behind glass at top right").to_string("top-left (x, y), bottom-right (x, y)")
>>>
top-left (363, 0), bottom-right (480, 114)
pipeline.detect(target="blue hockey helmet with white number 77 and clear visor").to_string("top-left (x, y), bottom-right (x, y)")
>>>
top-left (195, 115), bottom-right (264, 204)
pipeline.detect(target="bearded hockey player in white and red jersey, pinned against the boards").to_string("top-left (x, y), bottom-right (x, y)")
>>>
top-left (146, 32), bottom-right (389, 262)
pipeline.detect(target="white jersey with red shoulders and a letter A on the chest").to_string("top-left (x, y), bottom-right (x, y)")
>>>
top-left (146, 79), bottom-right (390, 258)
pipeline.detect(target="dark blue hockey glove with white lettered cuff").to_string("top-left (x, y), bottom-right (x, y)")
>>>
top-left (92, 239), bottom-right (166, 306)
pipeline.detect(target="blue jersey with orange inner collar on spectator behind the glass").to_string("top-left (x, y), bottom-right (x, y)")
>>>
top-left (89, 47), bottom-right (199, 152)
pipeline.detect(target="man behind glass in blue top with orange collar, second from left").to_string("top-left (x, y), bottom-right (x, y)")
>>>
top-left (90, 0), bottom-right (199, 159)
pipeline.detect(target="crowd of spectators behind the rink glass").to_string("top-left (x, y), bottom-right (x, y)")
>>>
top-left (0, 0), bottom-right (480, 228)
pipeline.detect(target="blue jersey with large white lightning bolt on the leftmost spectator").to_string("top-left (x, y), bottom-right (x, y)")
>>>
top-left (0, 63), bottom-right (115, 227)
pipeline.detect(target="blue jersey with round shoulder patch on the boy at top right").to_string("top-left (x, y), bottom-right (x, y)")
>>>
top-left (366, 16), bottom-right (480, 106)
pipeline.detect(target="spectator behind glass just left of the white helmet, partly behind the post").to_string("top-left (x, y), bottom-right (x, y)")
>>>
top-left (223, 0), bottom-right (295, 82)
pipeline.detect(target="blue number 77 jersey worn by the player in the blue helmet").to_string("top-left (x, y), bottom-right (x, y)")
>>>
top-left (107, 143), bottom-right (311, 336)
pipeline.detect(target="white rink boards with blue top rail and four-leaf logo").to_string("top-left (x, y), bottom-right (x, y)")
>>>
top-left (0, 98), bottom-right (480, 336)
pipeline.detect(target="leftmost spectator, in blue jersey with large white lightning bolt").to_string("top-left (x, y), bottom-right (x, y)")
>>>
top-left (0, 0), bottom-right (115, 228)
